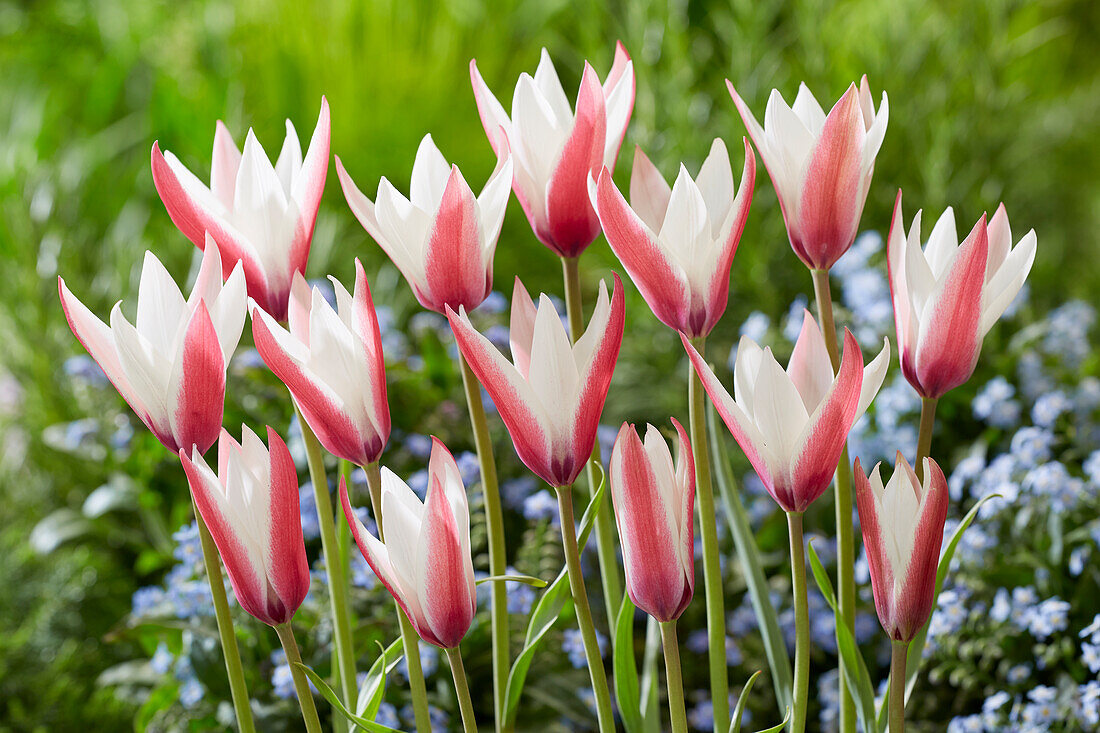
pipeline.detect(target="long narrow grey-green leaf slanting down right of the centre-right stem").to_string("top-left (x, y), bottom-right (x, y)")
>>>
top-left (706, 407), bottom-right (794, 707)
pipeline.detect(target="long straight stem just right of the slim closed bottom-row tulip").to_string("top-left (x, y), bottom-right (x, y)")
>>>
top-left (688, 337), bottom-right (729, 733)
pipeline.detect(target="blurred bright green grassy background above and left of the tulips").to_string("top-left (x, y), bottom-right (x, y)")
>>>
top-left (0, 0), bottom-right (1100, 731)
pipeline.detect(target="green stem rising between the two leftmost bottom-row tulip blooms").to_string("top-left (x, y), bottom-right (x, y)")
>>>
top-left (294, 403), bottom-right (358, 710)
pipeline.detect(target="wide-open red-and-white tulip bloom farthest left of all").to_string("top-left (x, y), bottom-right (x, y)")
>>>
top-left (57, 238), bottom-right (245, 452)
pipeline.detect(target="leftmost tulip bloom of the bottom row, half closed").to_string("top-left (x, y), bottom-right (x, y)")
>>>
top-left (179, 427), bottom-right (309, 626)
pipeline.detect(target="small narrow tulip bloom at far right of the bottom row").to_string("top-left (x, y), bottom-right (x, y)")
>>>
top-left (854, 451), bottom-right (948, 642)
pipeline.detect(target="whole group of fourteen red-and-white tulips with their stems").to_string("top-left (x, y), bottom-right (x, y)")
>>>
top-left (58, 39), bottom-right (1036, 733)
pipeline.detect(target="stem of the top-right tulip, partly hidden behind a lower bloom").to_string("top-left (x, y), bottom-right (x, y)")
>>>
top-left (811, 270), bottom-right (856, 733)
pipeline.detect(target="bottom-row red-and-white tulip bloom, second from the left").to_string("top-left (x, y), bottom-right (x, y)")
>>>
top-left (340, 438), bottom-right (477, 649)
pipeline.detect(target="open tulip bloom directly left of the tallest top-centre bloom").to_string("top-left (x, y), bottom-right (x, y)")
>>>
top-left (337, 134), bottom-right (513, 313)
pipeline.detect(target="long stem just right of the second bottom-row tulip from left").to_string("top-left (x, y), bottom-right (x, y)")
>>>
top-left (459, 353), bottom-right (512, 731)
